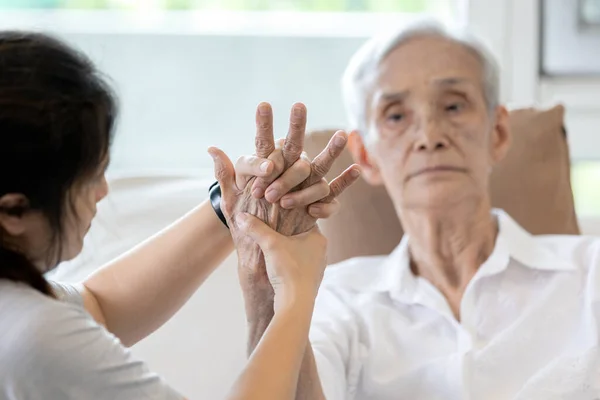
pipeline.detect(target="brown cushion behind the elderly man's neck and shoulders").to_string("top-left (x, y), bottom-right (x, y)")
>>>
top-left (306, 106), bottom-right (580, 263)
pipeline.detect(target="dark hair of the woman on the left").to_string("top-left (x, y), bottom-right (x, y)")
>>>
top-left (0, 31), bottom-right (117, 296)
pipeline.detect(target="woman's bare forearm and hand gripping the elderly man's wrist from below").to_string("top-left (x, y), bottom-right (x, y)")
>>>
top-left (228, 214), bottom-right (327, 400)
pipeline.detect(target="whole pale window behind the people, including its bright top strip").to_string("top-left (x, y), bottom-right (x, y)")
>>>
top-left (0, 0), bottom-right (466, 176)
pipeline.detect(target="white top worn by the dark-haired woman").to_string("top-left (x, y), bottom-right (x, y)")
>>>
top-left (0, 280), bottom-right (182, 400)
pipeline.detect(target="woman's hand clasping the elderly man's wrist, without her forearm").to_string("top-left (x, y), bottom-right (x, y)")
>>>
top-left (237, 213), bottom-right (327, 311)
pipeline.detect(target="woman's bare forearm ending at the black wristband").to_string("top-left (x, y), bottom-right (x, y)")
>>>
top-left (83, 201), bottom-right (233, 345)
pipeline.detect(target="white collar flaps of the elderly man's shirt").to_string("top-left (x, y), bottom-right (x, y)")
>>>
top-left (372, 209), bottom-right (575, 302)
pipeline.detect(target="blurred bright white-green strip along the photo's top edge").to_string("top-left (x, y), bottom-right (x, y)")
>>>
top-left (0, 0), bottom-right (452, 15)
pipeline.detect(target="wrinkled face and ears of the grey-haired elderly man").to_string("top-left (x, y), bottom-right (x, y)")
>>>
top-left (350, 37), bottom-right (509, 210)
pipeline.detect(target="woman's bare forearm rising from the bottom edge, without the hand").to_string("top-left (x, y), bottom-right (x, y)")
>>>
top-left (227, 297), bottom-right (314, 400)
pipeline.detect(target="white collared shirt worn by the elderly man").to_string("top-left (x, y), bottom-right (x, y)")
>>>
top-left (310, 211), bottom-right (600, 400)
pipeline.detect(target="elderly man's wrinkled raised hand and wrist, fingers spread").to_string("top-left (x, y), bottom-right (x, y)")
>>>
top-left (215, 104), bottom-right (359, 300)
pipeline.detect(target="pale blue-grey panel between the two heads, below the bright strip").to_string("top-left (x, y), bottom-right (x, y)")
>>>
top-left (63, 35), bottom-right (363, 170)
